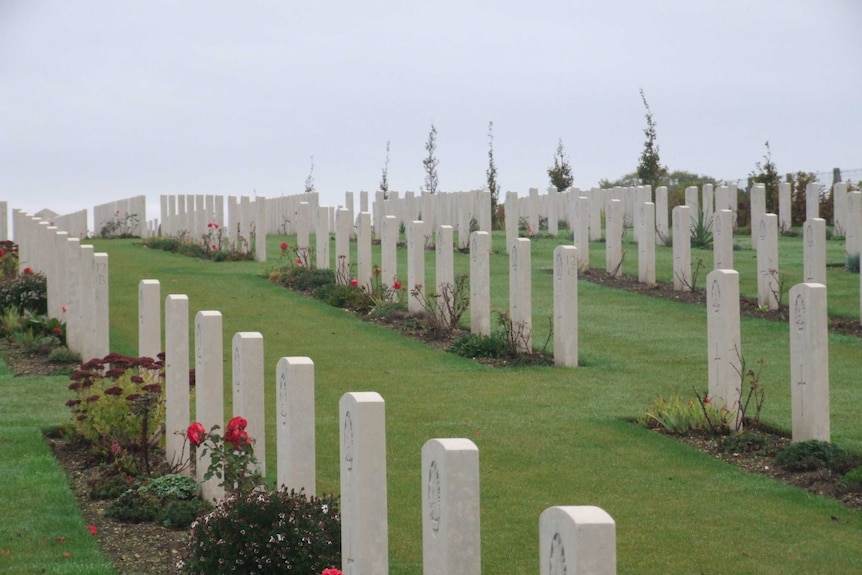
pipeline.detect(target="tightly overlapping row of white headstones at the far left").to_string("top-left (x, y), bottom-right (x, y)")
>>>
top-left (12, 209), bottom-right (110, 359)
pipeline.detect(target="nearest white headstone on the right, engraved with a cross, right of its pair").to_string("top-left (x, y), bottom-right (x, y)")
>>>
top-left (790, 283), bottom-right (830, 441)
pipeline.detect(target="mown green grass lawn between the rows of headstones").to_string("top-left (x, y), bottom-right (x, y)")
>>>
top-left (0, 233), bottom-right (862, 574)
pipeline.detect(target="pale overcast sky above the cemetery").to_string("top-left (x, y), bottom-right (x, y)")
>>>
top-left (0, 0), bottom-right (862, 226)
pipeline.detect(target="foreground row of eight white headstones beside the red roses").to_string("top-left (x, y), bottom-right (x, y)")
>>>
top-left (139, 280), bottom-right (616, 575)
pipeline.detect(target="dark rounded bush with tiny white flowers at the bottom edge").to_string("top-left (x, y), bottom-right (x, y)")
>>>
top-left (181, 490), bottom-right (341, 575)
